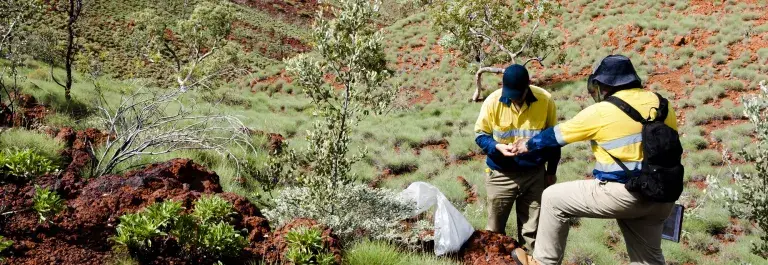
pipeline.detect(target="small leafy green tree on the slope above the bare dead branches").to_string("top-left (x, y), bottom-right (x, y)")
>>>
top-left (132, 1), bottom-right (242, 91)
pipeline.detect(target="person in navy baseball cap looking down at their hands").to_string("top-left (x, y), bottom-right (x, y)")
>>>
top-left (475, 64), bottom-right (560, 249)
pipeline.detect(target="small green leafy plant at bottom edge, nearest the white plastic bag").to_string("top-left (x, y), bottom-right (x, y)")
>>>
top-left (285, 226), bottom-right (336, 265)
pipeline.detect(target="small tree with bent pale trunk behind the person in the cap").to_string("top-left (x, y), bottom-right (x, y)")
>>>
top-left (432, 0), bottom-right (557, 101)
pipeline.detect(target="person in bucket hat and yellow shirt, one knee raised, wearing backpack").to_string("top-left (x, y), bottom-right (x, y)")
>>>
top-left (512, 55), bottom-right (682, 265)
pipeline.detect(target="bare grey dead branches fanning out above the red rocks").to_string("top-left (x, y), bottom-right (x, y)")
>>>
top-left (90, 87), bottom-right (255, 176)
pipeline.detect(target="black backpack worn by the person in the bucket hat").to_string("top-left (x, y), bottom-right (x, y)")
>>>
top-left (606, 93), bottom-right (684, 202)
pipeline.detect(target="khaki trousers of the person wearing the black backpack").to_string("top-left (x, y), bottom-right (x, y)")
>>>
top-left (533, 180), bottom-right (674, 265)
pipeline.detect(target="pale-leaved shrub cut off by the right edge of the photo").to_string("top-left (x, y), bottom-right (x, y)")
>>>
top-left (734, 81), bottom-right (768, 258)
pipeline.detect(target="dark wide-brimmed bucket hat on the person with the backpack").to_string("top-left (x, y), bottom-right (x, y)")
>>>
top-left (588, 55), bottom-right (641, 87)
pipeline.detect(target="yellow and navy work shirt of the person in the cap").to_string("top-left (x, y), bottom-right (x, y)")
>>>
top-left (475, 86), bottom-right (560, 175)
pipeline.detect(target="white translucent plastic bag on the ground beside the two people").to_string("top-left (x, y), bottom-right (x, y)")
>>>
top-left (400, 182), bottom-right (475, 256)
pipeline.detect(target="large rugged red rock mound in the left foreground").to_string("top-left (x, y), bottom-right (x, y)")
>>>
top-left (0, 157), bottom-right (269, 264)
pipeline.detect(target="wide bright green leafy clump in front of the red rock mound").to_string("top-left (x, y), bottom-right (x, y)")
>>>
top-left (112, 195), bottom-right (248, 259)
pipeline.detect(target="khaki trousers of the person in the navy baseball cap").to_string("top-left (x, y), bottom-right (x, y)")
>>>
top-left (485, 166), bottom-right (547, 249)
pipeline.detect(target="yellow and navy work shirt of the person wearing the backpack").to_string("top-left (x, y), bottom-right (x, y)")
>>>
top-left (528, 88), bottom-right (677, 183)
